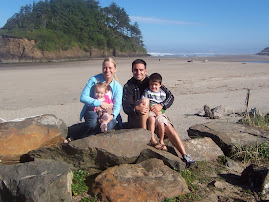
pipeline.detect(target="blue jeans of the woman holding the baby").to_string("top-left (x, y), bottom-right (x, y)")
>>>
top-left (80, 110), bottom-right (116, 135)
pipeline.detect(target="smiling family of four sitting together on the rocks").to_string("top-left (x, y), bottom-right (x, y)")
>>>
top-left (66, 57), bottom-right (194, 164)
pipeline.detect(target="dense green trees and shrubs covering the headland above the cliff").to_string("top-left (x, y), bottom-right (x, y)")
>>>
top-left (0, 0), bottom-right (146, 53)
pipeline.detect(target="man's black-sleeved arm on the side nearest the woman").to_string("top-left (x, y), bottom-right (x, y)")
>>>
top-left (122, 83), bottom-right (135, 116)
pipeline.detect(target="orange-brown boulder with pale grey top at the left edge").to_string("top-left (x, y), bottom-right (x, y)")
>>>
top-left (0, 114), bottom-right (67, 161)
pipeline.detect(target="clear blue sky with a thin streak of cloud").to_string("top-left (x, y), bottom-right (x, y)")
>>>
top-left (0, 0), bottom-right (269, 54)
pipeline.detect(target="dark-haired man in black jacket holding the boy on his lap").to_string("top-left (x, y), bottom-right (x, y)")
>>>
top-left (122, 59), bottom-right (195, 166)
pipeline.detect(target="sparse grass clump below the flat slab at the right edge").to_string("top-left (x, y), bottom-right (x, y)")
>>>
top-left (232, 142), bottom-right (269, 164)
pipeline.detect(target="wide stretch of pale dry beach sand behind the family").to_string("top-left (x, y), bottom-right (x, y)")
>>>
top-left (0, 56), bottom-right (269, 139)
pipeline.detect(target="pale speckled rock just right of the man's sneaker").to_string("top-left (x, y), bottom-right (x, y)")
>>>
top-left (184, 137), bottom-right (224, 161)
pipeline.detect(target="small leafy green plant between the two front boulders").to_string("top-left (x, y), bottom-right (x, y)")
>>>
top-left (72, 170), bottom-right (89, 196)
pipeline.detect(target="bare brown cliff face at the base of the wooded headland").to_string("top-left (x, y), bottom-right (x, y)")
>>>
top-left (0, 36), bottom-right (148, 63)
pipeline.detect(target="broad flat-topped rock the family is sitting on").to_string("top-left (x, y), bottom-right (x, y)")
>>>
top-left (23, 129), bottom-right (151, 170)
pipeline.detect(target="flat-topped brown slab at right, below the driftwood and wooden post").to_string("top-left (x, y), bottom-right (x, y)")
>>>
top-left (188, 122), bottom-right (269, 156)
